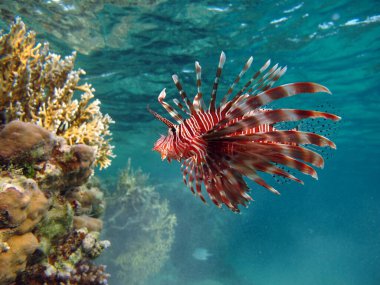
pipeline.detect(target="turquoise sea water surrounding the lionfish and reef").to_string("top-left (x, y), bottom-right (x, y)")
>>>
top-left (0, 0), bottom-right (380, 285)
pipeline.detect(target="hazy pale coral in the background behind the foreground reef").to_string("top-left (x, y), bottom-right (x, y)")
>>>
top-left (105, 161), bottom-right (176, 285)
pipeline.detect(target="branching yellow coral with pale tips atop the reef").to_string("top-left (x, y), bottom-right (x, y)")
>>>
top-left (0, 18), bottom-right (114, 168)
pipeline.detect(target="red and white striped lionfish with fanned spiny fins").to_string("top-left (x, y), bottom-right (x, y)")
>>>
top-left (148, 52), bottom-right (340, 212)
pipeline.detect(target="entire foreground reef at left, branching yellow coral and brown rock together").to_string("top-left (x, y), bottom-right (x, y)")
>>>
top-left (0, 19), bottom-right (112, 285)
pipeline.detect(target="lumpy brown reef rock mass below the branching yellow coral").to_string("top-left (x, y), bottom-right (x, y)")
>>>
top-left (0, 121), bottom-right (109, 285)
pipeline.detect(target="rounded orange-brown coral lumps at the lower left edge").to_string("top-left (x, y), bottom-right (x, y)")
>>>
top-left (0, 175), bottom-right (49, 285)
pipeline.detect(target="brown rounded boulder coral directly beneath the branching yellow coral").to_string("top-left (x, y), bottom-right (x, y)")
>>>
top-left (0, 121), bottom-right (96, 189)
